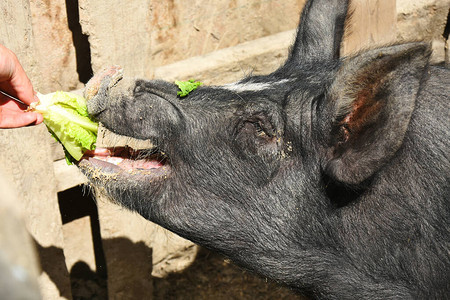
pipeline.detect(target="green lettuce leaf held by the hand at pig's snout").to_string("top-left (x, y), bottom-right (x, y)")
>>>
top-left (31, 92), bottom-right (98, 163)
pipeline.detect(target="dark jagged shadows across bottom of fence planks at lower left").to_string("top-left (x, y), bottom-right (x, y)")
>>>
top-left (35, 238), bottom-right (152, 300)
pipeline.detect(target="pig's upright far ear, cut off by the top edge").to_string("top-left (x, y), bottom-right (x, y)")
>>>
top-left (288, 0), bottom-right (348, 63)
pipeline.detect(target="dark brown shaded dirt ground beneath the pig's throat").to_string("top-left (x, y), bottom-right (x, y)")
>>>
top-left (153, 249), bottom-right (306, 300)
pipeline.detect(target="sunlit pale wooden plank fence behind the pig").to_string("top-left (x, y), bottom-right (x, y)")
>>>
top-left (0, 0), bottom-right (449, 299)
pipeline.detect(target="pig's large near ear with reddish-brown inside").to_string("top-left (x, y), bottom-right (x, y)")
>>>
top-left (324, 43), bottom-right (431, 184)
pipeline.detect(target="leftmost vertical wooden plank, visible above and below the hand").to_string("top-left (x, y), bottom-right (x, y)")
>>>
top-left (0, 0), bottom-right (72, 299)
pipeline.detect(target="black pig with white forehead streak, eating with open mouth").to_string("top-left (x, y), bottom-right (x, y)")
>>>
top-left (79, 0), bottom-right (450, 299)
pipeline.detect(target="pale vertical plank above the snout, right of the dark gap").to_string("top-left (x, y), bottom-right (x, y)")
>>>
top-left (79, 0), bottom-right (151, 77)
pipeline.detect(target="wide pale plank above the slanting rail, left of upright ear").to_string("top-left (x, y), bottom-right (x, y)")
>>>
top-left (151, 0), bottom-right (305, 67)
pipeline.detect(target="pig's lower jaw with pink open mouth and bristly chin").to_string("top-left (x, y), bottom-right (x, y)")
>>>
top-left (78, 147), bottom-right (170, 180)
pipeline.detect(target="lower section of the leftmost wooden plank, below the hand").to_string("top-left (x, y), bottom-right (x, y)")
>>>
top-left (0, 124), bottom-right (72, 299)
